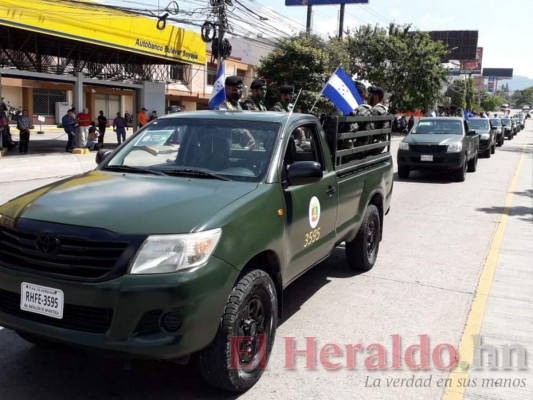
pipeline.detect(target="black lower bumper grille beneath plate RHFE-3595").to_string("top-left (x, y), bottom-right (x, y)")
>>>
top-left (0, 289), bottom-right (113, 333)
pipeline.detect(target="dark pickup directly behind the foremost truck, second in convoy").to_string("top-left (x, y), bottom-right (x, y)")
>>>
top-left (397, 117), bottom-right (479, 182)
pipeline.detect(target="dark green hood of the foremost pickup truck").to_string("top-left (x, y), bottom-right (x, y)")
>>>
top-left (0, 171), bottom-right (257, 234)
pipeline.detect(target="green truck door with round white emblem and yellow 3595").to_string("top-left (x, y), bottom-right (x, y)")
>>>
top-left (281, 124), bottom-right (338, 280)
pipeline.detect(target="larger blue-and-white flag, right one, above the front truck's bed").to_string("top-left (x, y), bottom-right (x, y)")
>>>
top-left (322, 67), bottom-right (363, 115)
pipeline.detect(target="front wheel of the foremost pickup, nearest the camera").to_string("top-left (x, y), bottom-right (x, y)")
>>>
top-left (197, 270), bottom-right (278, 392)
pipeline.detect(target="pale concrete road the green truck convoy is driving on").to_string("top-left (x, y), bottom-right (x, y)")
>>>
top-left (0, 121), bottom-right (533, 400)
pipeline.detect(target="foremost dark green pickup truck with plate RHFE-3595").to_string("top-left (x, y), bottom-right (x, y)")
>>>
top-left (0, 111), bottom-right (393, 391)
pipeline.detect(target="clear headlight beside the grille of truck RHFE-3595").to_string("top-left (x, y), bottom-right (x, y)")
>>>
top-left (130, 228), bottom-right (222, 274)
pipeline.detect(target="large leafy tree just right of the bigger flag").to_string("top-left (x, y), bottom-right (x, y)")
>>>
top-left (340, 24), bottom-right (448, 113)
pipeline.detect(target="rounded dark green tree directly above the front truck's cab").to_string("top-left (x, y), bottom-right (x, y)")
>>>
top-left (257, 33), bottom-right (348, 112)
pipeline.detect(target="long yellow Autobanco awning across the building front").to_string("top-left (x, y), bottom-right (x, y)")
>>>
top-left (0, 0), bottom-right (206, 65)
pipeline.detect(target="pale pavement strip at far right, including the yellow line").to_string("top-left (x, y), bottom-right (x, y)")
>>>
top-left (443, 123), bottom-right (533, 400)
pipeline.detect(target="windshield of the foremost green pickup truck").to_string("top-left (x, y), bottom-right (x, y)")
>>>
top-left (102, 117), bottom-right (281, 182)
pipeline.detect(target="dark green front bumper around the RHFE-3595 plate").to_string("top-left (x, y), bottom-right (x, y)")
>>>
top-left (0, 257), bottom-right (238, 359)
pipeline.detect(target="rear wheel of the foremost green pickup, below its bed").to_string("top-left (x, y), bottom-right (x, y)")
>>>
top-left (346, 204), bottom-right (381, 272)
